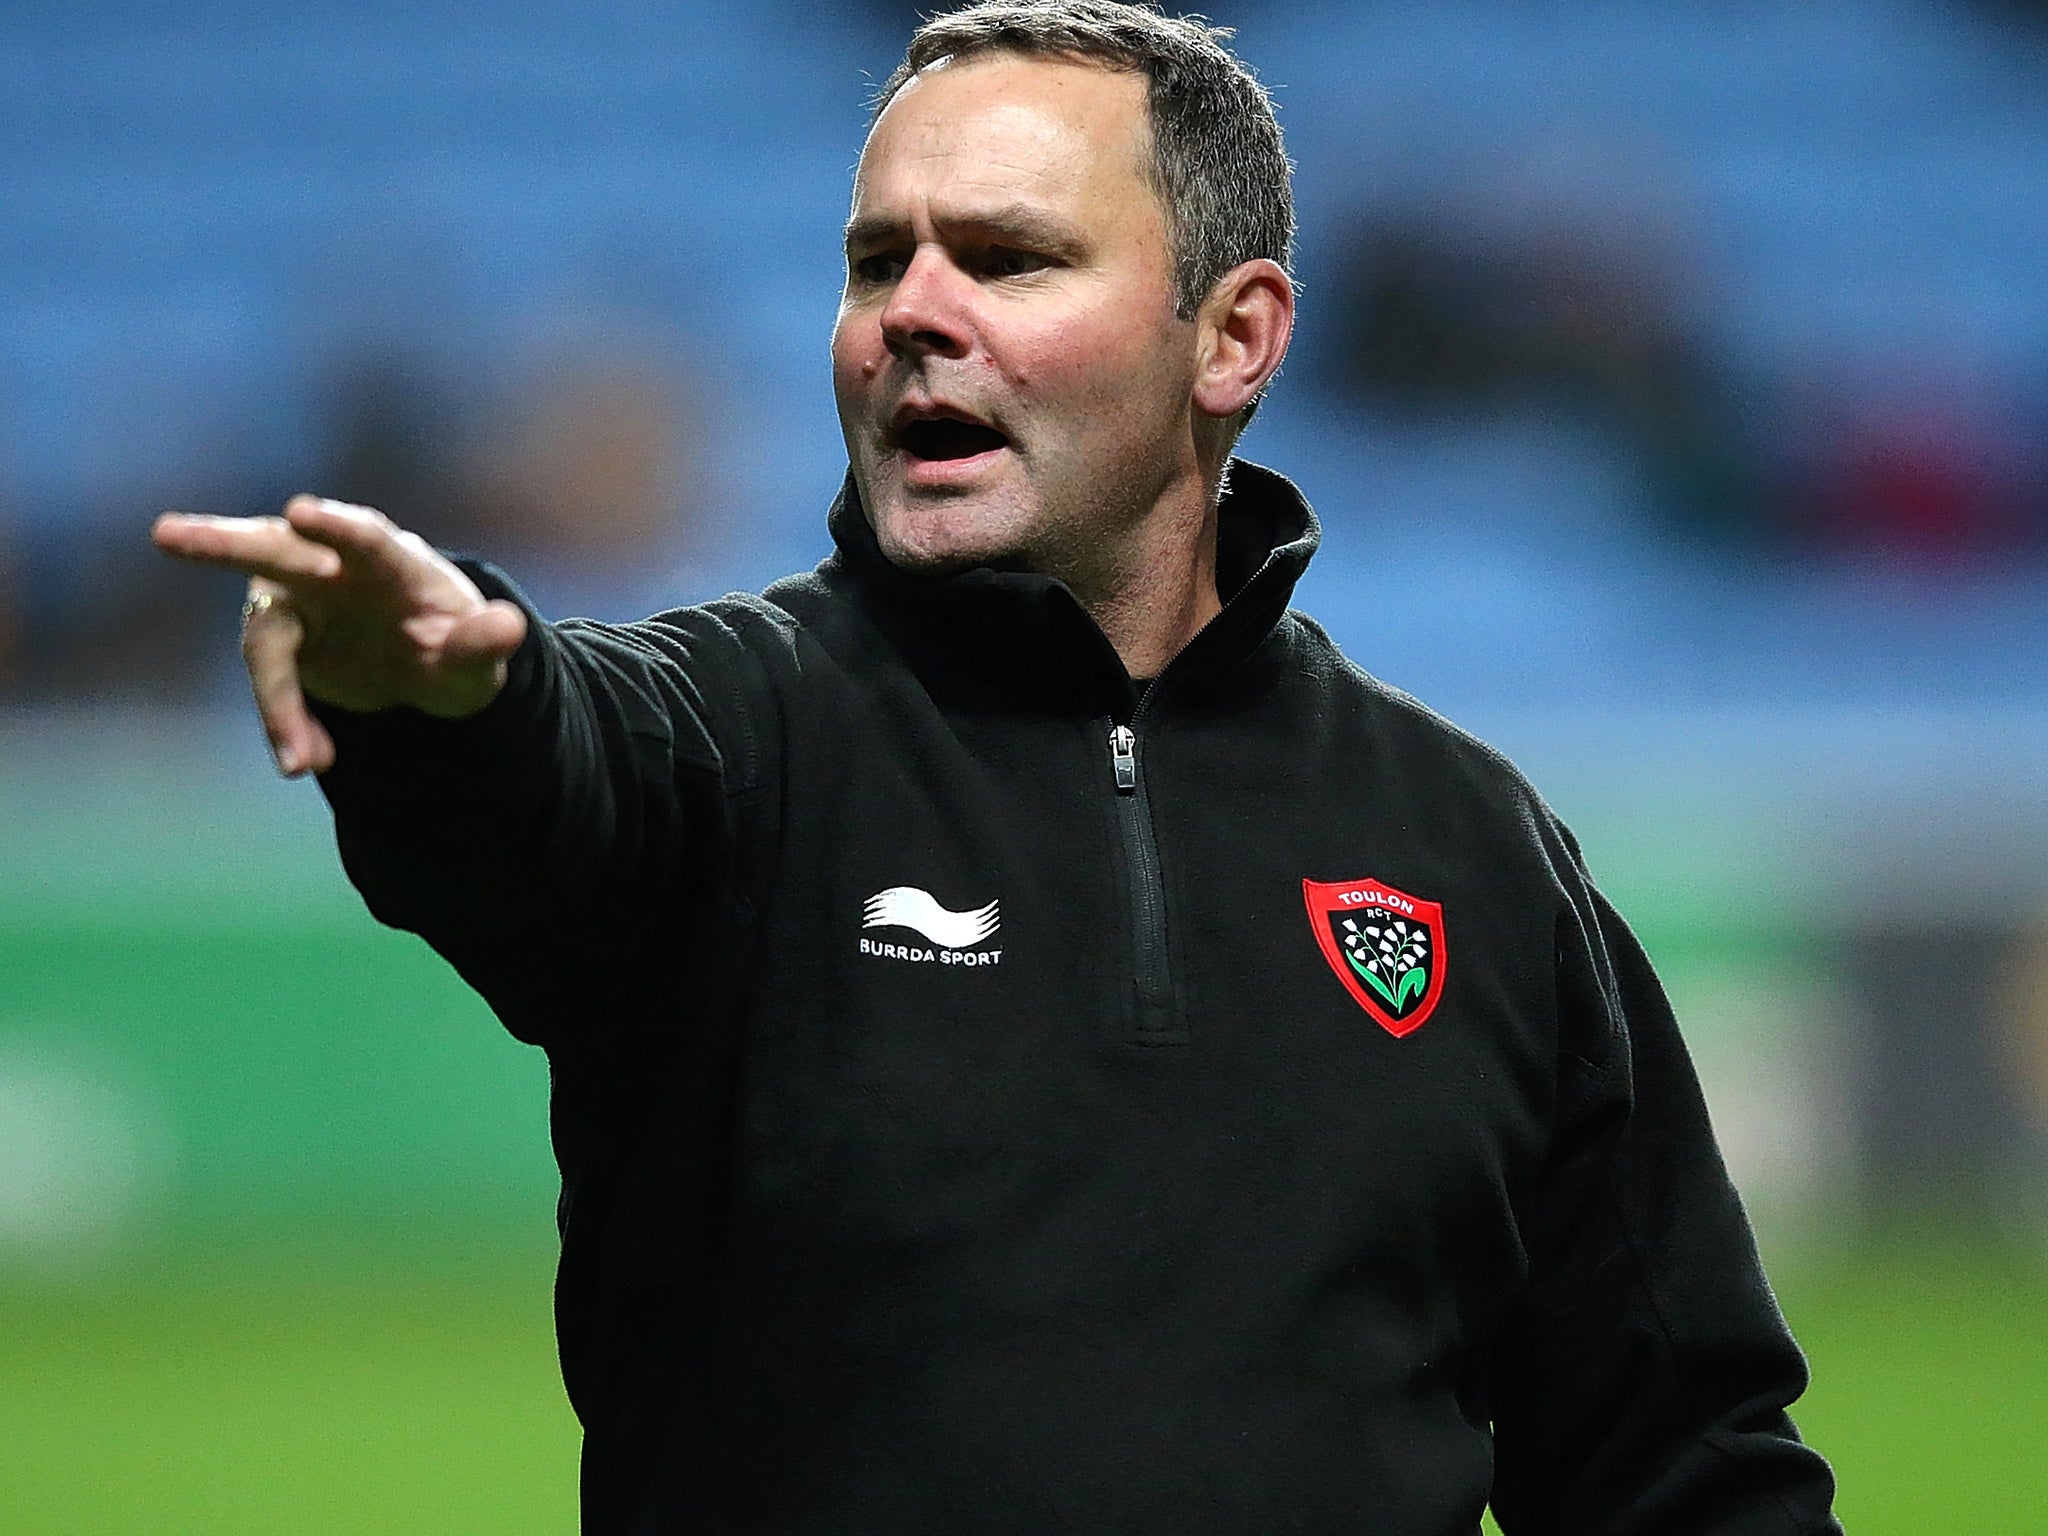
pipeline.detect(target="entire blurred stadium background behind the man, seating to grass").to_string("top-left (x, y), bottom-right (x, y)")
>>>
top-left (0, 0), bottom-right (2048, 1536)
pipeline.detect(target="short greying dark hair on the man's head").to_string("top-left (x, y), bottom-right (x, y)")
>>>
top-left (874, 0), bottom-right (1294, 319)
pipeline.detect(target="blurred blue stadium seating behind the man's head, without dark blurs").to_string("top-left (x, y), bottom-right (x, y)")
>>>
top-left (0, 0), bottom-right (2048, 707)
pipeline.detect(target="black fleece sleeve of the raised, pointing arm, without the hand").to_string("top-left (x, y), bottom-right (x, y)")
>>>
top-left (317, 563), bottom-right (762, 1044)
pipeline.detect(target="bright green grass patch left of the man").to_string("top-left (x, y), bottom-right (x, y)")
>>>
top-left (0, 1251), bottom-right (578, 1536)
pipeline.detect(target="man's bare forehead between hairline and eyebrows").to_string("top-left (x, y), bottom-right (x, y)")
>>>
top-left (854, 53), bottom-right (1151, 205)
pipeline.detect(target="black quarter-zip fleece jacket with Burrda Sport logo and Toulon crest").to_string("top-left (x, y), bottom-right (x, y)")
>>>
top-left (324, 463), bottom-right (1837, 1536)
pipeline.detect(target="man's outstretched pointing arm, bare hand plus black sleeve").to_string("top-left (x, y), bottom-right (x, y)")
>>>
top-left (156, 496), bottom-right (774, 1040)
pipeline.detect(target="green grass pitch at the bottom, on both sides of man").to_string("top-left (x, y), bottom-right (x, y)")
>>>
top-left (0, 1243), bottom-right (2048, 1536)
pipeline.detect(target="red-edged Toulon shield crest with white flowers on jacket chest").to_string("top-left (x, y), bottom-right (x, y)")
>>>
top-left (1300, 881), bottom-right (1444, 1038)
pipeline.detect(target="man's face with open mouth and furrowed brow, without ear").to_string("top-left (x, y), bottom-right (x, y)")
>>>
top-left (831, 53), bottom-right (1196, 571)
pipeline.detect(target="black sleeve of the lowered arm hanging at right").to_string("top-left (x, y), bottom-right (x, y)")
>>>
top-left (1493, 831), bottom-right (1841, 1536)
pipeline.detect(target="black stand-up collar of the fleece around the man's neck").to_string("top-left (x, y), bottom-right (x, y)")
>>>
top-left (819, 459), bottom-right (1321, 719)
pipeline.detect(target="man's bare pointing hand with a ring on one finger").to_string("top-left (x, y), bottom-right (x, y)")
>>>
top-left (152, 496), bottom-right (526, 776)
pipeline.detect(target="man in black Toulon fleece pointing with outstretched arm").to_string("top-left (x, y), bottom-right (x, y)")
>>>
top-left (158, 0), bottom-right (1837, 1536)
